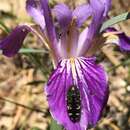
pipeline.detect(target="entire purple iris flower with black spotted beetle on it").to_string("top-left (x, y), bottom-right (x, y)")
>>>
top-left (0, 0), bottom-right (130, 130)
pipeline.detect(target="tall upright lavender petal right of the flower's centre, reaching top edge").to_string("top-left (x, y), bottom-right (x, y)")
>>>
top-left (77, 0), bottom-right (111, 55)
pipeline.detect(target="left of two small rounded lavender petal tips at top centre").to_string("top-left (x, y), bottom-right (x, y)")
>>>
top-left (53, 4), bottom-right (72, 29)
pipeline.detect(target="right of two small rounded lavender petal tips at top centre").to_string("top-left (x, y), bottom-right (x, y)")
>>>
top-left (73, 4), bottom-right (92, 27)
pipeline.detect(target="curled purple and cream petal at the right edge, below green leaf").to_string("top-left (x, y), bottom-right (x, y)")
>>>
top-left (106, 28), bottom-right (130, 51)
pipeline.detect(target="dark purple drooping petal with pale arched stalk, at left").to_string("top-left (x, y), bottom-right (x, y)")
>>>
top-left (0, 24), bottom-right (46, 57)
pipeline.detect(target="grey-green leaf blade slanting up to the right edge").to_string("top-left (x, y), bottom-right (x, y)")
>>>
top-left (100, 12), bottom-right (130, 32)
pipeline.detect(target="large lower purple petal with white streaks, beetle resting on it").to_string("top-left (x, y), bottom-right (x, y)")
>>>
top-left (46, 57), bottom-right (109, 130)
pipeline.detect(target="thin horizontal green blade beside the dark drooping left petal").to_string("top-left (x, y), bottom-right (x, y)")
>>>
top-left (19, 48), bottom-right (47, 53)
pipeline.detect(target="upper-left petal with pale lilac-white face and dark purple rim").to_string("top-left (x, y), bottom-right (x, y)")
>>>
top-left (26, 0), bottom-right (45, 30)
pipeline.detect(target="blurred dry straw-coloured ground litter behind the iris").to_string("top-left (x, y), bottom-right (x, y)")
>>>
top-left (0, 0), bottom-right (130, 130)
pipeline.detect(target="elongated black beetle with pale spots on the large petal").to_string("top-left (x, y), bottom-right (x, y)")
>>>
top-left (67, 85), bottom-right (81, 123)
